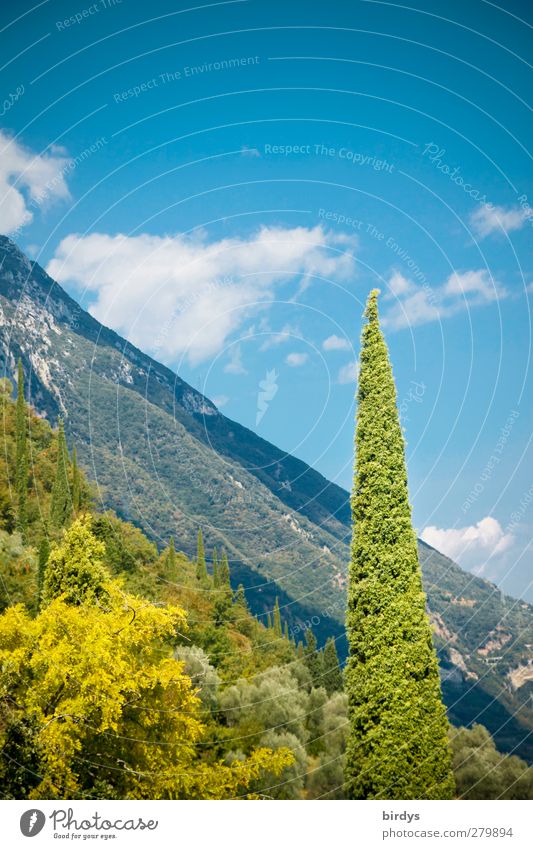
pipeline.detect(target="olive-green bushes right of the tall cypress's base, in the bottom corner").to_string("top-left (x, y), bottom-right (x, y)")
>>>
top-left (450, 725), bottom-right (533, 799)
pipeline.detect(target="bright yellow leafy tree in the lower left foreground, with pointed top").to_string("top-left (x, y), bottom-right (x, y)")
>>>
top-left (0, 519), bottom-right (292, 799)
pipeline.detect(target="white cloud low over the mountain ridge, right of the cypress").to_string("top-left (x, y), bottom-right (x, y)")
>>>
top-left (420, 516), bottom-right (514, 562)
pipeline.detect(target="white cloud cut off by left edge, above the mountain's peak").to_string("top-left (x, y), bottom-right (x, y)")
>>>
top-left (0, 130), bottom-right (71, 234)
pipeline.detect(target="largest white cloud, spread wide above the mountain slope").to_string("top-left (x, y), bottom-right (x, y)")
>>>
top-left (47, 226), bottom-right (354, 364)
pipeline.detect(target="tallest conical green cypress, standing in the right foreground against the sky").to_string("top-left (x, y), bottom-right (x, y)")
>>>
top-left (345, 290), bottom-right (454, 799)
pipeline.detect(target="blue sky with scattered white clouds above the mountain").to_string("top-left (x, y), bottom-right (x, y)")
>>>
top-left (0, 0), bottom-right (533, 600)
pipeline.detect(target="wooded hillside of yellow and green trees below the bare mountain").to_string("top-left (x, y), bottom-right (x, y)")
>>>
top-left (0, 338), bottom-right (533, 799)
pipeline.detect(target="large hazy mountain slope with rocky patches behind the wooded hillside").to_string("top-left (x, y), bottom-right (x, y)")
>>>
top-left (0, 237), bottom-right (533, 762)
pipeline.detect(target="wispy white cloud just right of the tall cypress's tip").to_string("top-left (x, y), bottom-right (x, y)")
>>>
top-left (383, 269), bottom-right (502, 330)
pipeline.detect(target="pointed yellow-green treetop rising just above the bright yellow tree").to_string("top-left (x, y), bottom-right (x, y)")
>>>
top-left (42, 516), bottom-right (109, 605)
